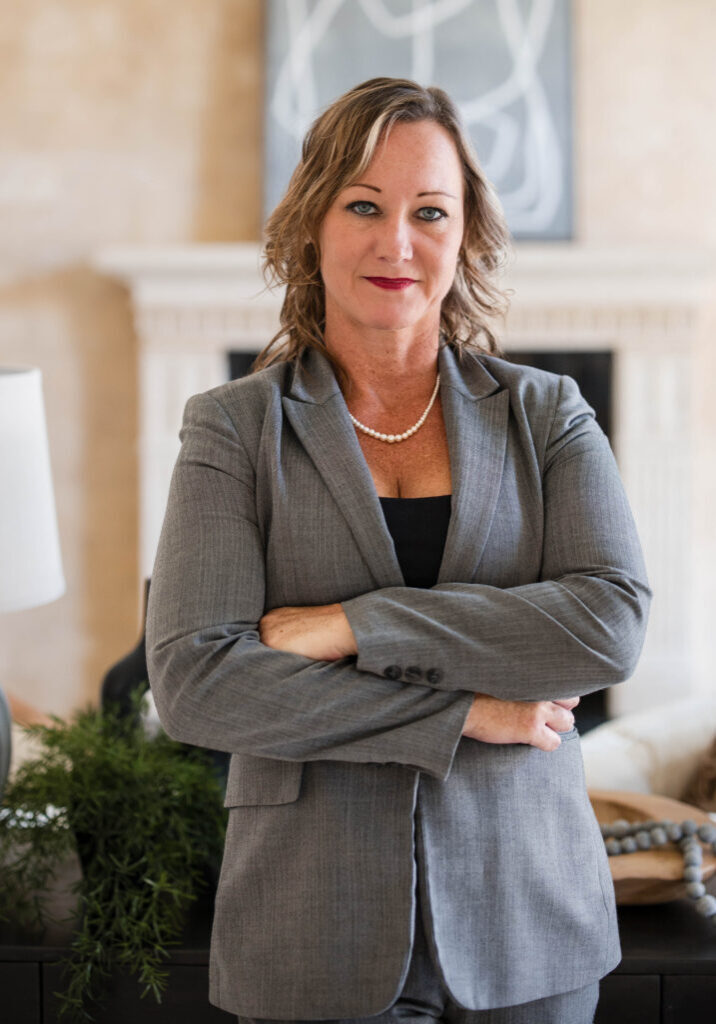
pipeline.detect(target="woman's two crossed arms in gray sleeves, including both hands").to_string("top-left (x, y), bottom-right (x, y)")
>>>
top-left (146, 380), bottom-right (649, 778)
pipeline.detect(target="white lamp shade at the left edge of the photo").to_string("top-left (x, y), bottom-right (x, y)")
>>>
top-left (0, 367), bottom-right (65, 611)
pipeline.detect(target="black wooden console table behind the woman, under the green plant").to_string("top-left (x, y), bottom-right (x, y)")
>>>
top-left (0, 900), bottom-right (716, 1024)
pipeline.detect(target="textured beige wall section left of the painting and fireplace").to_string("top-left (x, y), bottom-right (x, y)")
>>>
top-left (0, 0), bottom-right (262, 714)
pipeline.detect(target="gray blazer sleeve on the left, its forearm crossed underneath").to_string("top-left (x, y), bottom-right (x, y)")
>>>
top-left (146, 394), bottom-right (472, 779)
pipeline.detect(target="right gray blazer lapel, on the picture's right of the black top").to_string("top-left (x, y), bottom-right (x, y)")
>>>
top-left (437, 347), bottom-right (509, 583)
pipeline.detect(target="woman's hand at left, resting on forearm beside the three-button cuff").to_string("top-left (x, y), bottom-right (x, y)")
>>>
top-left (258, 604), bottom-right (357, 662)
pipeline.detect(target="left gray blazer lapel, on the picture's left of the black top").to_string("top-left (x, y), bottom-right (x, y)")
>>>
top-left (283, 349), bottom-right (405, 588)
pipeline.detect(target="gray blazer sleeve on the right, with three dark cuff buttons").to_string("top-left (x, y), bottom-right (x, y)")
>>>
top-left (342, 377), bottom-right (650, 700)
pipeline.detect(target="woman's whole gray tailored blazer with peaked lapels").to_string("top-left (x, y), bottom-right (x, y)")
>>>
top-left (146, 348), bottom-right (650, 1019)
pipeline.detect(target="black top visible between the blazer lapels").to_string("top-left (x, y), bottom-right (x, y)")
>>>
top-left (380, 495), bottom-right (451, 587)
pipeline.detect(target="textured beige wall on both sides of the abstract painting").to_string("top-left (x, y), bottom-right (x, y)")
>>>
top-left (0, 0), bottom-right (716, 713)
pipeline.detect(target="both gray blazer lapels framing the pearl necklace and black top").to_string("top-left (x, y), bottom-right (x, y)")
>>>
top-left (283, 346), bottom-right (509, 588)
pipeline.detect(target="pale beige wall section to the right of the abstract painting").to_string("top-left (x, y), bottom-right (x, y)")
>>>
top-left (574, 0), bottom-right (716, 247)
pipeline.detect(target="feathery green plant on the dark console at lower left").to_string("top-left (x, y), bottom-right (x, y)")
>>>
top-left (0, 695), bottom-right (225, 1021)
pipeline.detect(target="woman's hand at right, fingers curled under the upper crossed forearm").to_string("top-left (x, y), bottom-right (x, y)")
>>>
top-left (462, 693), bottom-right (580, 751)
